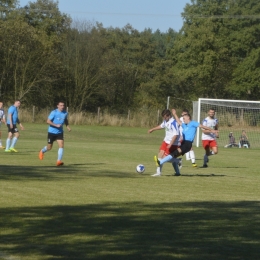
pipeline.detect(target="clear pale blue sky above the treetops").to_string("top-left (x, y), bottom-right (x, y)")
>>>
top-left (16, 0), bottom-right (190, 32)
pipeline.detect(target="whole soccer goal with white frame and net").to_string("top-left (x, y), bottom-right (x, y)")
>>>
top-left (193, 98), bottom-right (260, 148)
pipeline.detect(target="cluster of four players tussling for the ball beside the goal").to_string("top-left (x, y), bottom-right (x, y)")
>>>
top-left (148, 108), bottom-right (218, 177)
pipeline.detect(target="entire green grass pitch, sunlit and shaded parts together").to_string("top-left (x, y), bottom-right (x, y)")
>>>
top-left (0, 124), bottom-right (260, 260)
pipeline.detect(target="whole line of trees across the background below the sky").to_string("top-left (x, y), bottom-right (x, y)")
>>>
top-left (0, 0), bottom-right (260, 113)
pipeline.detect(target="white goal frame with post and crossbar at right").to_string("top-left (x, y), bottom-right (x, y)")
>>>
top-left (193, 98), bottom-right (260, 147)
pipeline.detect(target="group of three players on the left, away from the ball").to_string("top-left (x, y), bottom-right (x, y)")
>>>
top-left (0, 100), bottom-right (71, 166)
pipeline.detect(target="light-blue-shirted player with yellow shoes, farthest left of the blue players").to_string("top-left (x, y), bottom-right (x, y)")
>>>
top-left (5, 100), bottom-right (24, 153)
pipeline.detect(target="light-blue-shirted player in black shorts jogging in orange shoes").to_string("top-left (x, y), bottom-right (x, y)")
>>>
top-left (39, 102), bottom-right (71, 166)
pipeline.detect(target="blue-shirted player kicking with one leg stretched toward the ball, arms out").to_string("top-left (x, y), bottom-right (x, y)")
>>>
top-left (155, 109), bottom-right (218, 175)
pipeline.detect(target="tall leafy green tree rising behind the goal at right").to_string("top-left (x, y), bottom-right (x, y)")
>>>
top-left (171, 0), bottom-right (260, 99)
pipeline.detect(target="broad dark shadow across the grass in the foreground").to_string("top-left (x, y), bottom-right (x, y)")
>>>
top-left (0, 201), bottom-right (260, 260)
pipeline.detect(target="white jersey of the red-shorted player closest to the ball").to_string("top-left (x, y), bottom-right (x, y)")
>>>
top-left (161, 118), bottom-right (181, 145)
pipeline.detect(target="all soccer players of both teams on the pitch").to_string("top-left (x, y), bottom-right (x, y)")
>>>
top-left (0, 100), bottom-right (218, 172)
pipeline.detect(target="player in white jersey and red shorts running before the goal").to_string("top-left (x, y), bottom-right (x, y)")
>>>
top-left (201, 108), bottom-right (218, 168)
